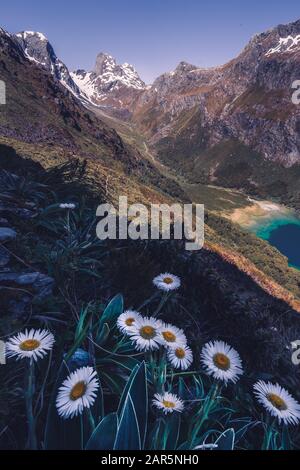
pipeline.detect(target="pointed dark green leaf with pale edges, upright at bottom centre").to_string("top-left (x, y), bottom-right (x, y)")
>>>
top-left (114, 394), bottom-right (142, 450)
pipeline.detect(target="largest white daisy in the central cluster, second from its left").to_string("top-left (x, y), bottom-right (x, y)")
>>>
top-left (128, 317), bottom-right (162, 351)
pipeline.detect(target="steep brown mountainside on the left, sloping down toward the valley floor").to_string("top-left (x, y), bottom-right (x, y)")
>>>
top-left (0, 25), bottom-right (182, 206)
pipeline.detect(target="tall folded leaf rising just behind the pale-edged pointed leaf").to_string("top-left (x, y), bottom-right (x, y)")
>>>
top-left (117, 361), bottom-right (148, 448)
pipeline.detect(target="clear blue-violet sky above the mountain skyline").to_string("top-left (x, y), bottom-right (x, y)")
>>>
top-left (0, 0), bottom-right (300, 83)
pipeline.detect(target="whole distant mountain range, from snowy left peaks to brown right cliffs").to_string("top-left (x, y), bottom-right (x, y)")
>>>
top-left (12, 20), bottom-right (300, 197)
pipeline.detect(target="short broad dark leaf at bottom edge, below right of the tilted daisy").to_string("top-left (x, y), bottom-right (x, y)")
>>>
top-left (86, 413), bottom-right (118, 450)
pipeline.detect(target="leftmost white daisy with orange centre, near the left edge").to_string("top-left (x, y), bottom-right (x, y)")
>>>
top-left (6, 329), bottom-right (55, 361)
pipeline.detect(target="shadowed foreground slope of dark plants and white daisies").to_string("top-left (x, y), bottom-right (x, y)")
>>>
top-left (0, 154), bottom-right (300, 452)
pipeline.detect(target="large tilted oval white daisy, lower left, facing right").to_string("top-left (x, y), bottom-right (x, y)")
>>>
top-left (56, 367), bottom-right (99, 419)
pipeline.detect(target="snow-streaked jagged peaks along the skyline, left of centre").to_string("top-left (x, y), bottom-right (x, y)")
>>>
top-left (14, 31), bottom-right (146, 114)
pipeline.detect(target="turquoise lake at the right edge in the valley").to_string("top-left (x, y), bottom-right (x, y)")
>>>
top-left (250, 212), bottom-right (300, 269)
